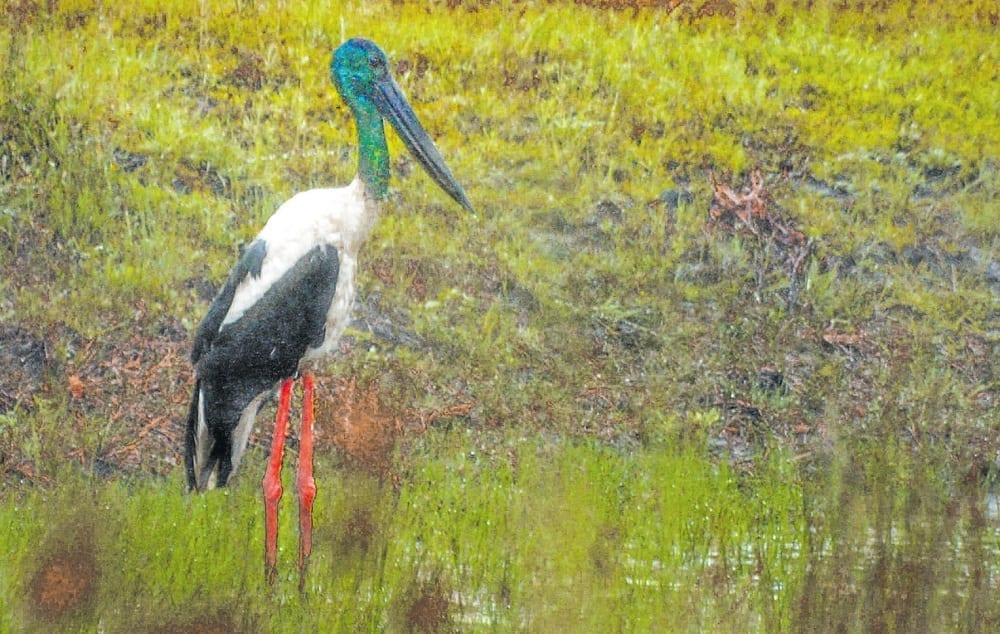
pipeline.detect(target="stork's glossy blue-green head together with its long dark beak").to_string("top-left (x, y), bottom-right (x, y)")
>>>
top-left (330, 38), bottom-right (473, 212)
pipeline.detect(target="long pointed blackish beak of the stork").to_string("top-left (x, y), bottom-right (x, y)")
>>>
top-left (374, 77), bottom-right (476, 214)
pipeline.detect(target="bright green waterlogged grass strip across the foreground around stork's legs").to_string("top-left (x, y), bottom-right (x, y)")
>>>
top-left (0, 430), bottom-right (1000, 632)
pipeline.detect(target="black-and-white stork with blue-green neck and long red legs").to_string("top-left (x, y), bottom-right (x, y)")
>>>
top-left (185, 39), bottom-right (473, 584)
